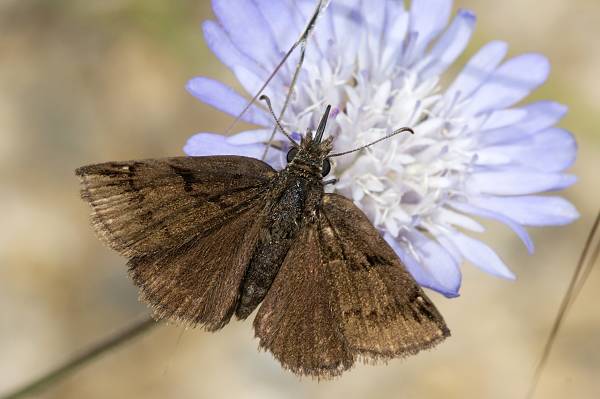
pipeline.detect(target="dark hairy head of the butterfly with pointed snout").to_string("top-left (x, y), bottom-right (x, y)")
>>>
top-left (287, 106), bottom-right (333, 177)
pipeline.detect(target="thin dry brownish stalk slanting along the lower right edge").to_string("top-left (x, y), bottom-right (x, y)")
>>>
top-left (526, 212), bottom-right (600, 399)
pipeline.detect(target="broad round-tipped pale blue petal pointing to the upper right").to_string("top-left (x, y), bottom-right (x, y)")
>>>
top-left (464, 53), bottom-right (550, 115)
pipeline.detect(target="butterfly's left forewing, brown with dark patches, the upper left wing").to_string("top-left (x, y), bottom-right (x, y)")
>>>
top-left (76, 156), bottom-right (276, 257)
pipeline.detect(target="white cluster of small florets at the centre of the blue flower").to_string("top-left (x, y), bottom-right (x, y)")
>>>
top-left (285, 57), bottom-right (475, 237)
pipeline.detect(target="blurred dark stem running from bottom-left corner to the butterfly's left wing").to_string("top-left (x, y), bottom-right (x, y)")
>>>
top-left (0, 317), bottom-right (159, 399)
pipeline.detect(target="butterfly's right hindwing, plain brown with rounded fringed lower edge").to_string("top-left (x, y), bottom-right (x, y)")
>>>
top-left (254, 224), bottom-right (353, 378)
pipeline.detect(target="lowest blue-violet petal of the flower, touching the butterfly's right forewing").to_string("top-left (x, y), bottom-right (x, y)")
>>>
top-left (384, 232), bottom-right (462, 298)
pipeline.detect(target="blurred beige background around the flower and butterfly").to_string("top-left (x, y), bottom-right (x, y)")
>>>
top-left (0, 0), bottom-right (600, 399)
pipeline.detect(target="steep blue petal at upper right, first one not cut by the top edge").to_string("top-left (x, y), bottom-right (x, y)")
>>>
top-left (421, 10), bottom-right (476, 80)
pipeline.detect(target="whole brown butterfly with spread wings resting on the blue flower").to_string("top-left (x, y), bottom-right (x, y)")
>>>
top-left (76, 104), bottom-right (450, 378)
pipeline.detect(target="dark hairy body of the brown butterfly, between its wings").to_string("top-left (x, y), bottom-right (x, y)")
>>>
top-left (236, 135), bottom-right (331, 319)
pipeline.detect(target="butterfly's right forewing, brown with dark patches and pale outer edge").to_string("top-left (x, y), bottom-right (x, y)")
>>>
top-left (320, 194), bottom-right (450, 362)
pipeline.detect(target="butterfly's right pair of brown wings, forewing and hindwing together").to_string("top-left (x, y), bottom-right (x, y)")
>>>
top-left (254, 194), bottom-right (449, 378)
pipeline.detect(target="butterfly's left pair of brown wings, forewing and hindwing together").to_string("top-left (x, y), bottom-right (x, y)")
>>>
top-left (76, 156), bottom-right (276, 330)
